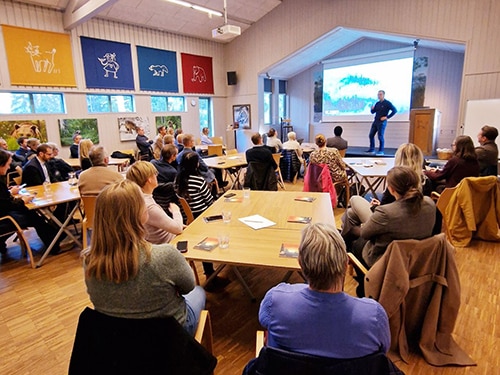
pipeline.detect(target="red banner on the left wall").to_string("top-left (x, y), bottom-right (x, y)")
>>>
top-left (181, 53), bottom-right (214, 94)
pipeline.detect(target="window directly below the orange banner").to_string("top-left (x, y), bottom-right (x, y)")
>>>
top-left (0, 92), bottom-right (65, 114)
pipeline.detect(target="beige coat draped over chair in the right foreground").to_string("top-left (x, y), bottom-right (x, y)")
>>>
top-left (365, 234), bottom-right (475, 366)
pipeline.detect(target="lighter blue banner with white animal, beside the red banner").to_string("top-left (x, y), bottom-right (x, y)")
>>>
top-left (137, 46), bottom-right (179, 92)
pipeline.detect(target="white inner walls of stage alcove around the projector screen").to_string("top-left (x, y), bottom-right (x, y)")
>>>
top-left (288, 41), bottom-right (464, 148)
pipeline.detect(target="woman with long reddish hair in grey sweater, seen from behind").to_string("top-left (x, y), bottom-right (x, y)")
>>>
top-left (83, 180), bottom-right (206, 334)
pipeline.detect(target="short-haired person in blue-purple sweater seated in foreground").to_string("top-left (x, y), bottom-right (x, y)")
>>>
top-left (259, 223), bottom-right (391, 358)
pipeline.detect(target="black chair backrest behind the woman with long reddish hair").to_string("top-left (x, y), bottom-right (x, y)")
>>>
top-left (68, 307), bottom-right (217, 375)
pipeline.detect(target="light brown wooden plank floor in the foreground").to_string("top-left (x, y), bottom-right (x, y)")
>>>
top-left (0, 183), bottom-right (500, 375)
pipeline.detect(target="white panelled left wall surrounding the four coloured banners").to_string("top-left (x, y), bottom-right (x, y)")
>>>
top-left (0, 1), bottom-right (231, 156)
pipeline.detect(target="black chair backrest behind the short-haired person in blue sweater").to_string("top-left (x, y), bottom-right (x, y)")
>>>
top-left (243, 346), bottom-right (396, 375)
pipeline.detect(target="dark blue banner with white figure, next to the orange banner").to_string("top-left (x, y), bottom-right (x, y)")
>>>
top-left (80, 36), bottom-right (134, 90)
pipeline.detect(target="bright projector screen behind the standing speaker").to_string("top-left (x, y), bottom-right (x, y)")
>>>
top-left (322, 48), bottom-right (413, 122)
